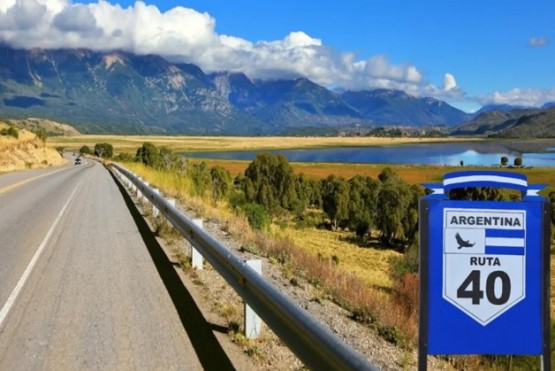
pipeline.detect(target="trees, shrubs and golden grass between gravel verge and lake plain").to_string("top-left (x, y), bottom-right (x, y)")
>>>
top-left (106, 142), bottom-right (555, 369)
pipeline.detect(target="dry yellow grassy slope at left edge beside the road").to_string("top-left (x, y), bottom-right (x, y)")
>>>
top-left (0, 121), bottom-right (65, 173)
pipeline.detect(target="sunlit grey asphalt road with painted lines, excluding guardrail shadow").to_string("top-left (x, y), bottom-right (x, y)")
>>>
top-left (0, 160), bottom-right (203, 370)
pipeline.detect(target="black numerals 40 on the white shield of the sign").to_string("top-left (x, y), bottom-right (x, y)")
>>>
top-left (457, 270), bottom-right (511, 305)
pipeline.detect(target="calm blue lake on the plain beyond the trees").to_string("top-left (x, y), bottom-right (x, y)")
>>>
top-left (183, 139), bottom-right (555, 167)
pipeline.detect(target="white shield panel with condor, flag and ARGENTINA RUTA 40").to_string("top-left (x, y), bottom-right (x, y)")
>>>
top-left (443, 208), bottom-right (526, 326)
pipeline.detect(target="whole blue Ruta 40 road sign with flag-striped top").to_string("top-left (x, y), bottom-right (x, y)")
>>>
top-left (419, 171), bottom-right (551, 370)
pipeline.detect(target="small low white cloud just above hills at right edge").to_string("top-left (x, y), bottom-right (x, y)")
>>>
top-left (478, 88), bottom-right (555, 107)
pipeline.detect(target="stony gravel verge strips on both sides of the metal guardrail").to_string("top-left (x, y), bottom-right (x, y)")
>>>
top-left (124, 176), bottom-right (450, 370)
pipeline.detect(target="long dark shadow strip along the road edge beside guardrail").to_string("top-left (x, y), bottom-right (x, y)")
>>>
top-left (110, 172), bottom-right (235, 370)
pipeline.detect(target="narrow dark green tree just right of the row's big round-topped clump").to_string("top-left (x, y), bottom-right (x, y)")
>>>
top-left (322, 175), bottom-right (350, 229)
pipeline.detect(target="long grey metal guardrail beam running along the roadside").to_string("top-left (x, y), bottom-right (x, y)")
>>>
top-left (112, 164), bottom-right (378, 370)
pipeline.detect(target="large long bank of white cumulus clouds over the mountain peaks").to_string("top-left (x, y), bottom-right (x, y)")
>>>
top-left (0, 0), bottom-right (452, 95)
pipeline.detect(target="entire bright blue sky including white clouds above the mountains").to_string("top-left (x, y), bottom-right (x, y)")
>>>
top-left (0, 0), bottom-right (555, 110)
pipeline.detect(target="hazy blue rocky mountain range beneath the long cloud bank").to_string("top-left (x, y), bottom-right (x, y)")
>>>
top-left (0, 46), bottom-right (478, 135)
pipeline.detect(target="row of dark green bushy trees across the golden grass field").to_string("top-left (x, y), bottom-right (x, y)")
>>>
top-left (128, 142), bottom-right (424, 248)
